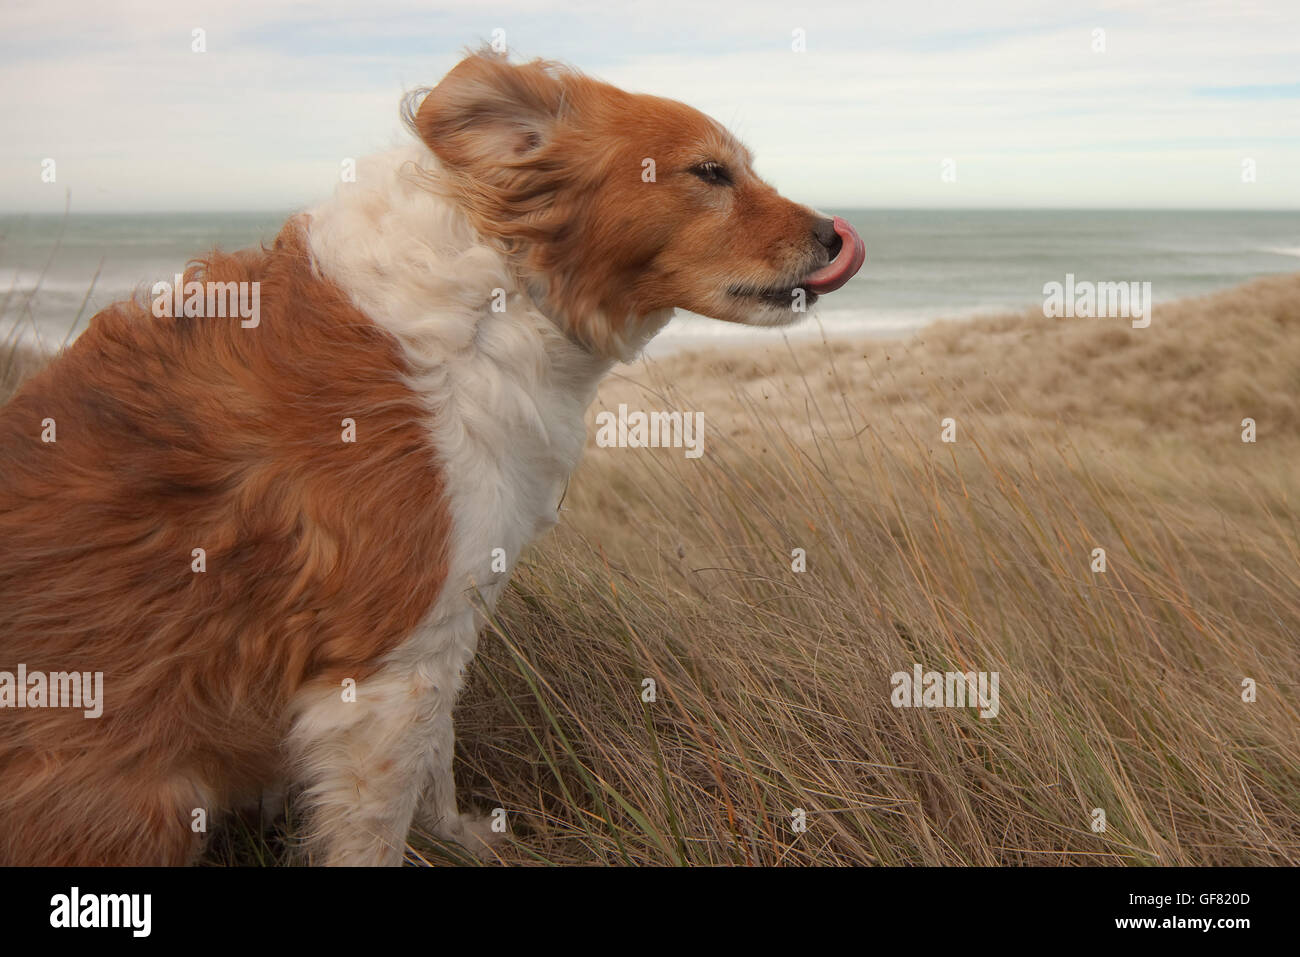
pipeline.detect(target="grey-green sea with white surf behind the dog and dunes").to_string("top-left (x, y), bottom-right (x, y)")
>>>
top-left (0, 209), bottom-right (1300, 351)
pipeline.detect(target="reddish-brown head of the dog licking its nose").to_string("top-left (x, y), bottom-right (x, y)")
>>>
top-left (408, 52), bottom-right (866, 352)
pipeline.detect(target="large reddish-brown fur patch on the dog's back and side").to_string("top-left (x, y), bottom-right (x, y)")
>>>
top-left (0, 221), bottom-right (450, 865)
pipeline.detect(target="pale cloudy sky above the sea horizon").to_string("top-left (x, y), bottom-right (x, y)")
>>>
top-left (0, 0), bottom-right (1300, 212)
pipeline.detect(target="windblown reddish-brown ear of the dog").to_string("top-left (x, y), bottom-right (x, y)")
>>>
top-left (407, 52), bottom-right (564, 174)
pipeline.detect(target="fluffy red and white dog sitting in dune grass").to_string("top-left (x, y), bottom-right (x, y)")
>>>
top-left (0, 53), bottom-right (865, 865)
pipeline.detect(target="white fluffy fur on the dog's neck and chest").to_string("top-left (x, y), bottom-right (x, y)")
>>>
top-left (302, 146), bottom-right (610, 666)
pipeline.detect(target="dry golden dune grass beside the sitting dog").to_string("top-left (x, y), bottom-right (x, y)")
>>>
top-left (2, 276), bottom-right (1300, 865)
